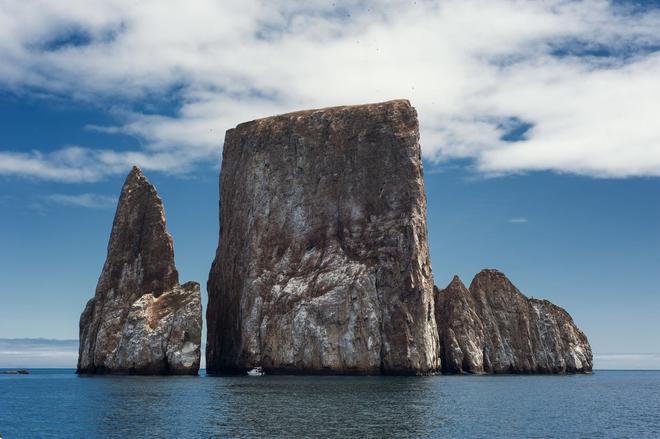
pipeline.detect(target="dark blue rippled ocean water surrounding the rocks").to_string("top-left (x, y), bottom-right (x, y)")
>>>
top-left (0, 369), bottom-right (660, 439)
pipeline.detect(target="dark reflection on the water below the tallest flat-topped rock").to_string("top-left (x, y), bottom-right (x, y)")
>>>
top-left (202, 377), bottom-right (436, 437)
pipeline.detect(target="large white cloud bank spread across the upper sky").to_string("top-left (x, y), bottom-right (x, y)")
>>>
top-left (0, 0), bottom-right (660, 181)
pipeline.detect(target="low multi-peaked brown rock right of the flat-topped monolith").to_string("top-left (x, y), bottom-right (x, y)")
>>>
top-left (435, 270), bottom-right (592, 373)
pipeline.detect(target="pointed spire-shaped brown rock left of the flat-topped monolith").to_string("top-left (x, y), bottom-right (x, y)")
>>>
top-left (78, 167), bottom-right (202, 375)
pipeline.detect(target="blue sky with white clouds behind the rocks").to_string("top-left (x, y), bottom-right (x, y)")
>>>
top-left (0, 0), bottom-right (660, 368)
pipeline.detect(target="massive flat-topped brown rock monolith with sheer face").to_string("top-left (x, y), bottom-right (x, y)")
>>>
top-left (206, 101), bottom-right (439, 373)
